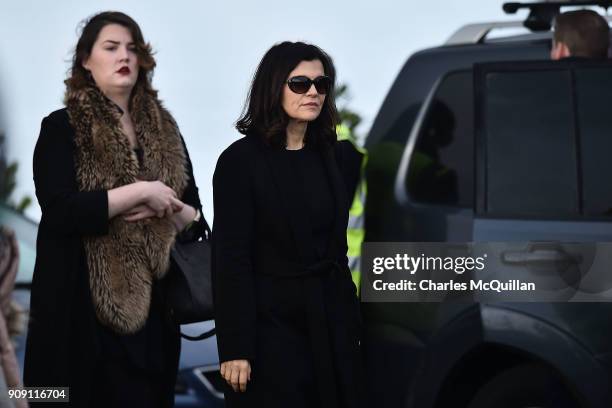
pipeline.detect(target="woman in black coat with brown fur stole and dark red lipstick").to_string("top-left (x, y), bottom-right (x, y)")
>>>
top-left (24, 12), bottom-right (204, 408)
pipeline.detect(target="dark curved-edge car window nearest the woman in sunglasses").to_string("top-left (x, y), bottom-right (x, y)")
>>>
top-left (406, 71), bottom-right (474, 208)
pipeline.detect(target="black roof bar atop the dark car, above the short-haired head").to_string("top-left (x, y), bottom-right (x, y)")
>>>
top-left (502, 0), bottom-right (612, 31)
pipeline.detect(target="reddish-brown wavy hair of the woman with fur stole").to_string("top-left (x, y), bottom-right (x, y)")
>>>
top-left (64, 11), bottom-right (157, 95)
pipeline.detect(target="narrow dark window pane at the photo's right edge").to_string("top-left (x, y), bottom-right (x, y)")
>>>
top-left (576, 68), bottom-right (612, 216)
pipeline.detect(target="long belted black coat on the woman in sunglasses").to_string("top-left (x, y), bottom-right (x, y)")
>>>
top-left (213, 136), bottom-right (363, 408)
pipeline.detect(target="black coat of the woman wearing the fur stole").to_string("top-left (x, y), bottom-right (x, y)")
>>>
top-left (24, 109), bottom-right (206, 407)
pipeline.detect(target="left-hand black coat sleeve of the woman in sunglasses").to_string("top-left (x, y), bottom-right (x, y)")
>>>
top-left (213, 147), bottom-right (256, 362)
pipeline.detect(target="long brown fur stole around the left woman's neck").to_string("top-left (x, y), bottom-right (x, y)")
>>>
top-left (66, 86), bottom-right (188, 334)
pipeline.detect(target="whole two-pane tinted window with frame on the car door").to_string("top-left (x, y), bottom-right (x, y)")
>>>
top-left (476, 61), bottom-right (612, 219)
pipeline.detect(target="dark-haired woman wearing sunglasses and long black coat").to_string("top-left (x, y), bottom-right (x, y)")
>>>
top-left (213, 42), bottom-right (362, 408)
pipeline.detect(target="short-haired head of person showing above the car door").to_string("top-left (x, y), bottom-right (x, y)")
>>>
top-left (550, 10), bottom-right (610, 60)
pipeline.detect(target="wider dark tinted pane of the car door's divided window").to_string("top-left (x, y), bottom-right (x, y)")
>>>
top-left (484, 71), bottom-right (578, 216)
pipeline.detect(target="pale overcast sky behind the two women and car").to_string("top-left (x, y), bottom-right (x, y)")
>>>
top-left (0, 0), bottom-right (524, 219)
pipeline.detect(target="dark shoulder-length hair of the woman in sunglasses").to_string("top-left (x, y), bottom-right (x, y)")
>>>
top-left (236, 41), bottom-right (338, 147)
